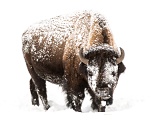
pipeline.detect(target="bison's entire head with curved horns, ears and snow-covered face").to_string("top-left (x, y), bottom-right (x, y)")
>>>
top-left (79, 44), bottom-right (125, 108)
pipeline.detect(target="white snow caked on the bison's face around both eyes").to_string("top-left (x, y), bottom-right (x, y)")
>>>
top-left (87, 59), bottom-right (118, 94)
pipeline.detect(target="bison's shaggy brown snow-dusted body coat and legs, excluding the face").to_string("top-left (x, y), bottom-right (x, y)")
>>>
top-left (22, 11), bottom-right (125, 111)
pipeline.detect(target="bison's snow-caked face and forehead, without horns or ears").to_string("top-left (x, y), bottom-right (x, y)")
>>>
top-left (84, 44), bottom-right (118, 99)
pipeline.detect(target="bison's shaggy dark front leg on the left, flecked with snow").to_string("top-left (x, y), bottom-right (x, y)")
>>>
top-left (67, 90), bottom-right (85, 112)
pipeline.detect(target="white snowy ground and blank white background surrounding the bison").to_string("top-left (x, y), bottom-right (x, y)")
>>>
top-left (0, 0), bottom-right (160, 125)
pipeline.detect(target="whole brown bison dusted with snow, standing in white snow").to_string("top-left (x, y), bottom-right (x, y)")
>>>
top-left (22, 11), bottom-right (125, 112)
